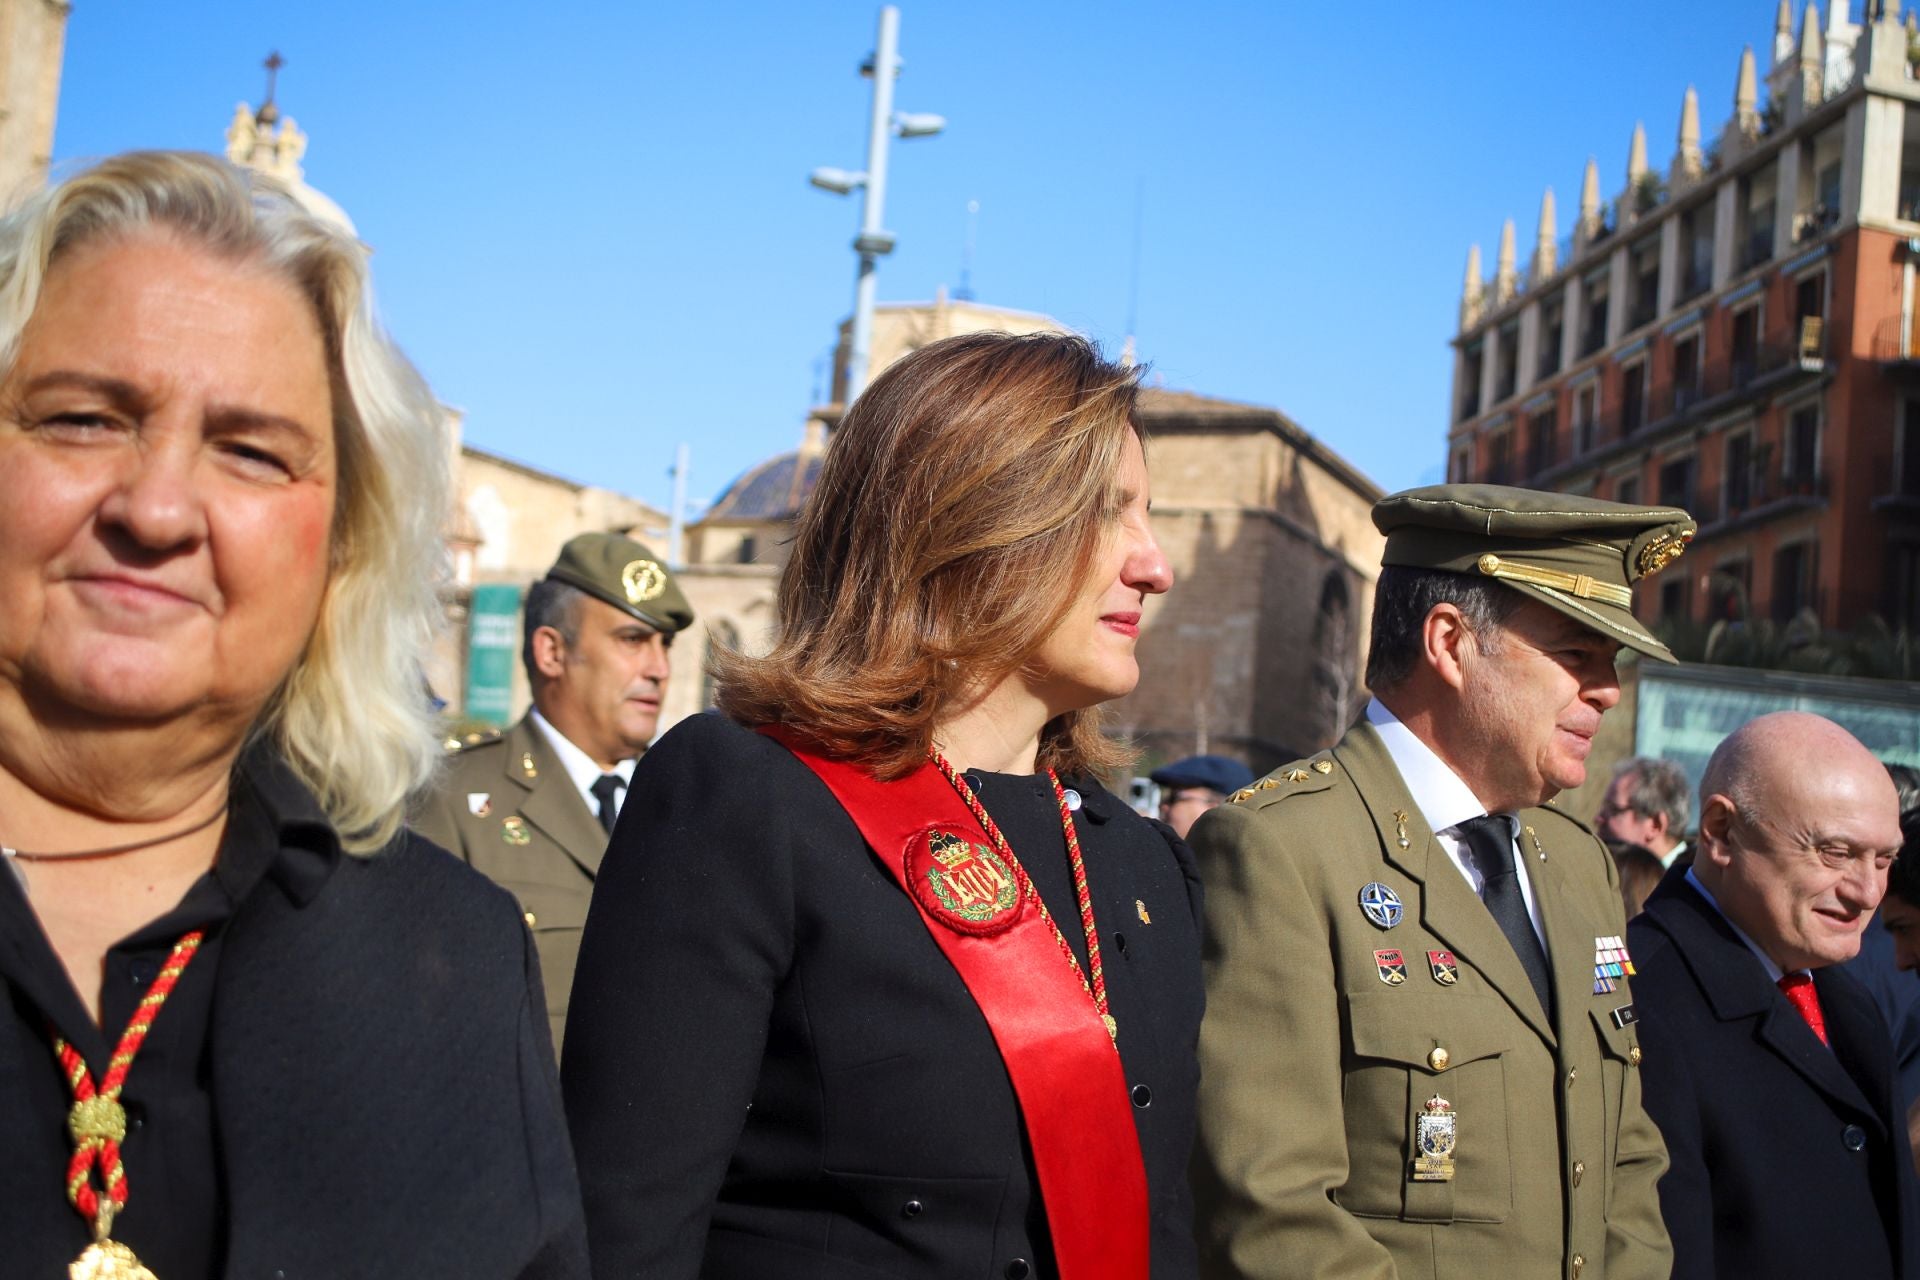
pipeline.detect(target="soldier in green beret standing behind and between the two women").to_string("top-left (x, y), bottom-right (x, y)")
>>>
top-left (415, 533), bottom-right (693, 1048)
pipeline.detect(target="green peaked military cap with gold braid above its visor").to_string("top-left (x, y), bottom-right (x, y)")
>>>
top-left (1373, 484), bottom-right (1695, 662)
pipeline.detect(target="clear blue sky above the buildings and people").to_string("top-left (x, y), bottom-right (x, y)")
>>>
top-left (54, 0), bottom-right (1781, 507)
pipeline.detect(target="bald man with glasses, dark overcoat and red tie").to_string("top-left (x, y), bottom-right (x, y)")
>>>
top-left (1626, 712), bottom-right (1920, 1280)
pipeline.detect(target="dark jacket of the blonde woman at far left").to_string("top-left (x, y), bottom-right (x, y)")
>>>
top-left (0, 752), bottom-right (588, 1280)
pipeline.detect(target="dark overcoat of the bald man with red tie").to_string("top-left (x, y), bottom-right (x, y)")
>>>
top-left (1626, 867), bottom-right (1920, 1280)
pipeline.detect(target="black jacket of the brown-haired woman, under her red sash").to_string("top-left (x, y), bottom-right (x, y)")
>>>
top-left (561, 716), bottom-right (1204, 1280)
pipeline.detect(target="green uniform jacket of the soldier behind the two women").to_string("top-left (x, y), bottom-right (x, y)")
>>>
top-left (413, 718), bottom-right (607, 1050)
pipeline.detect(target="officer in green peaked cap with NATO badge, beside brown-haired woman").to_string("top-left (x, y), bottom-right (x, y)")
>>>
top-left (1192, 486), bottom-right (1693, 1280)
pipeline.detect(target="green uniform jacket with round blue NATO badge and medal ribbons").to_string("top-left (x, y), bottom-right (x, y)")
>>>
top-left (1192, 723), bottom-right (1672, 1280)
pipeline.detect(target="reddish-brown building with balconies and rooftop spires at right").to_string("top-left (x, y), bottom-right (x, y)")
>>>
top-left (1448, 0), bottom-right (1920, 633)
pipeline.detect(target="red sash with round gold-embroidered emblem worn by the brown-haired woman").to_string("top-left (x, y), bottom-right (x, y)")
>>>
top-left (764, 729), bottom-right (1148, 1280)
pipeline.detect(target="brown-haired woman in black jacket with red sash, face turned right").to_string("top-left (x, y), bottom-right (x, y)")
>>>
top-left (563, 334), bottom-right (1202, 1280)
